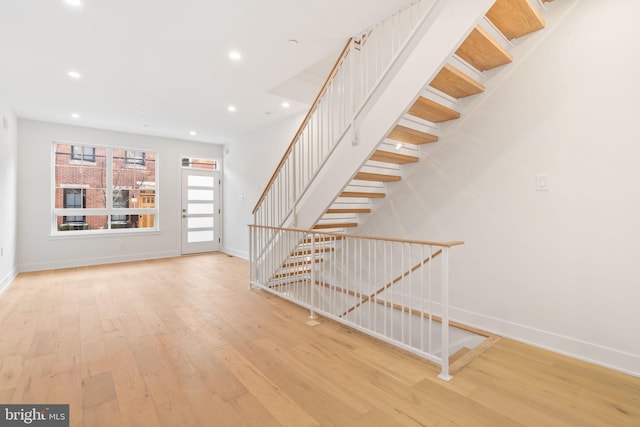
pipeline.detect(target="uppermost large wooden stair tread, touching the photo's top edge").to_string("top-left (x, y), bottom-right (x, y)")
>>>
top-left (486, 0), bottom-right (544, 40)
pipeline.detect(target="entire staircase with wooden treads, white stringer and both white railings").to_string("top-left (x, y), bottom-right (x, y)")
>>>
top-left (250, 0), bottom-right (550, 380)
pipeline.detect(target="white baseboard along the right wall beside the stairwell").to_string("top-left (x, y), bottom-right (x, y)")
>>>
top-left (449, 307), bottom-right (640, 377)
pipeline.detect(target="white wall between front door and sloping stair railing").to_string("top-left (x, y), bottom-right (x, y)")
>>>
top-left (222, 114), bottom-right (304, 258)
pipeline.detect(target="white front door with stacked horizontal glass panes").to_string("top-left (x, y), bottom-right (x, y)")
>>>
top-left (182, 169), bottom-right (220, 254)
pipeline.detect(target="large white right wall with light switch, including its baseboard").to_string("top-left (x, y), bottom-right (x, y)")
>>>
top-left (361, 0), bottom-right (640, 375)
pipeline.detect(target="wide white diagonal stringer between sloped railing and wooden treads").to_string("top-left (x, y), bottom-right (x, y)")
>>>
top-left (284, 0), bottom-right (493, 229)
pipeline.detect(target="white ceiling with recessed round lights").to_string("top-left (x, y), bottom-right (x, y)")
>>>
top-left (0, 0), bottom-right (409, 143)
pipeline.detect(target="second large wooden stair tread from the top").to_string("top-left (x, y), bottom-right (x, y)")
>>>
top-left (456, 26), bottom-right (512, 71)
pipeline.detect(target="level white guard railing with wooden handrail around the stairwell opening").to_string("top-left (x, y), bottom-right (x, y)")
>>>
top-left (250, 225), bottom-right (463, 380)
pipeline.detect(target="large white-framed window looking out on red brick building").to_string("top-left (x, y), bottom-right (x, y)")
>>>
top-left (51, 142), bottom-right (158, 234)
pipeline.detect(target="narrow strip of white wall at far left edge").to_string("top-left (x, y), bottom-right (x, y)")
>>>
top-left (0, 101), bottom-right (18, 292)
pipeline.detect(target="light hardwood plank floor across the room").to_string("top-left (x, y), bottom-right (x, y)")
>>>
top-left (0, 254), bottom-right (640, 427)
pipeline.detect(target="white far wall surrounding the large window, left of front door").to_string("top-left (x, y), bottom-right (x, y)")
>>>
top-left (18, 120), bottom-right (224, 271)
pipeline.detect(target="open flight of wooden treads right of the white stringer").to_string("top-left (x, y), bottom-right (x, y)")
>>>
top-left (313, 0), bottom-right (551, 232)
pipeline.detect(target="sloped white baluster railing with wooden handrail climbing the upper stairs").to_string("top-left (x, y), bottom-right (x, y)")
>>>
top-left (252, 0), bottom-right (433, 231)
